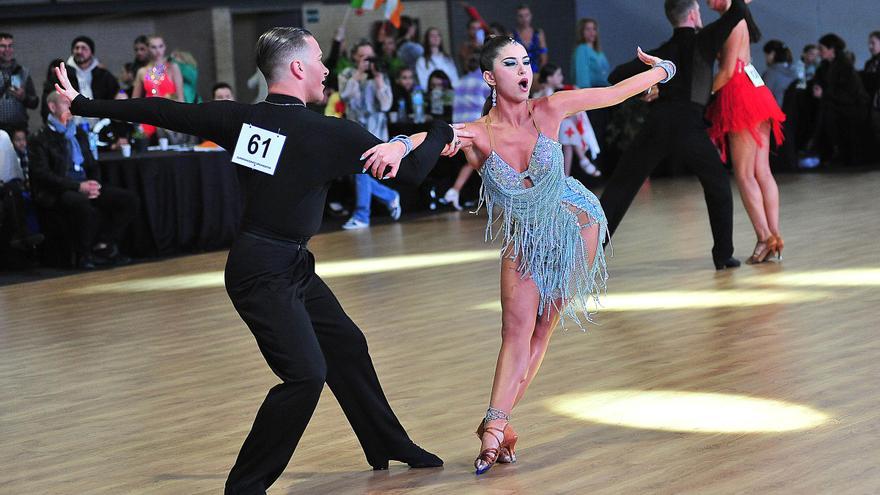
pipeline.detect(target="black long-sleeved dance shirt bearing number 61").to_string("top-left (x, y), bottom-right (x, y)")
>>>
top-left (71, 94), bottom-right (453, 239)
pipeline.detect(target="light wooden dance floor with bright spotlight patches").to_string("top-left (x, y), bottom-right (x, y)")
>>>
top-left (0, 172), bottom-right (880, 495)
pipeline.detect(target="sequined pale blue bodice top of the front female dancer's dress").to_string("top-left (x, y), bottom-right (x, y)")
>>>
top-left (483, 133), bottom-right (565, 191)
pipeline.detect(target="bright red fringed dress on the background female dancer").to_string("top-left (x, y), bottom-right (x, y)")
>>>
top-left (706, 60), bottom-right (785, 161)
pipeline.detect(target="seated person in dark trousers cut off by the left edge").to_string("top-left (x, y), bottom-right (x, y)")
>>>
top-left (0, 129), bottom-right (43, 250)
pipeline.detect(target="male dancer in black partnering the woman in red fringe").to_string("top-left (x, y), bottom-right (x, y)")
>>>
top-left (600, 0), bottom-right (747, 270)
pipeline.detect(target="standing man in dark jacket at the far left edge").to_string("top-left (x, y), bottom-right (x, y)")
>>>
top-left (0, 33), bottom-right (40, 134)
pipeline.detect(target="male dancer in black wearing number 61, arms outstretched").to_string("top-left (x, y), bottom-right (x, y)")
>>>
top-left (56, 27), bottom-right (465, 494)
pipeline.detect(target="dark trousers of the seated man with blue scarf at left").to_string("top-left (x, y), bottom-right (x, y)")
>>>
top-left (56, 184), bottom-right (139, 255)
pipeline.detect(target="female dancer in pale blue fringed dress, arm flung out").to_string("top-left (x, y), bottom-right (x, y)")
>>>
top-left (452, 37), bottom-right (675, 474)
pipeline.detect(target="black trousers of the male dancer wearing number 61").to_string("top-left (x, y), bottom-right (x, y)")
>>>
top-left (225, 231), bottom-right (412, 495)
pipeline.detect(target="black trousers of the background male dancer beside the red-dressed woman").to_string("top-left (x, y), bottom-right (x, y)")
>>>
top-left (600, 102), bottom-right (733, 263)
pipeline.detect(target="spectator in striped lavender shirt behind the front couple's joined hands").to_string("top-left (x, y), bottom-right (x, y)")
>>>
top-left (440, 50), bottom-right (491, 210)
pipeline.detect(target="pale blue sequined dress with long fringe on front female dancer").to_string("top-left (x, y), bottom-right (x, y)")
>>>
top-left (477, 112), bottom-right (608, 329)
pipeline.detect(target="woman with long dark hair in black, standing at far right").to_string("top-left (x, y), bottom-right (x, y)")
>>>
top-left (812, 34), bottom-right (868, 169)
